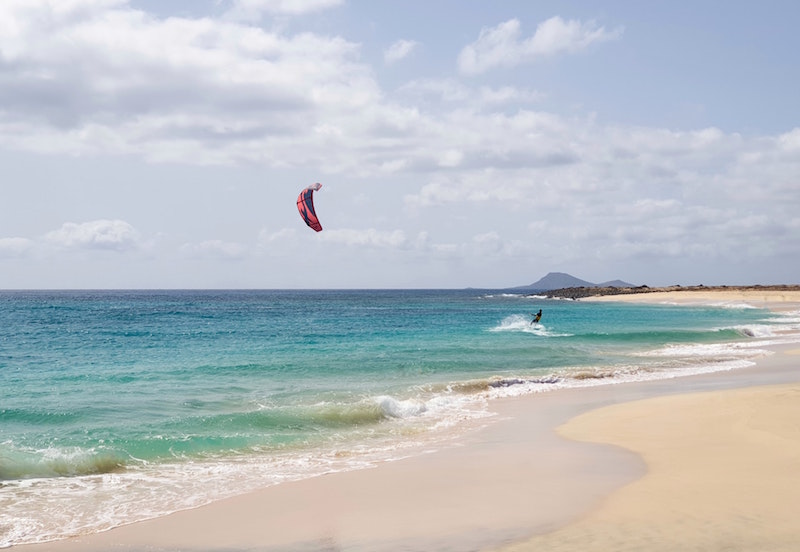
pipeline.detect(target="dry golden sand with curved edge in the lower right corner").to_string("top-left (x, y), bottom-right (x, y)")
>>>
top-left (502, 384), bottom-right (800, 552)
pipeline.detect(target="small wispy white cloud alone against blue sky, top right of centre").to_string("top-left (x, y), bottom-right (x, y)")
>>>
top-left (458, 16), bottom-right (623, 75)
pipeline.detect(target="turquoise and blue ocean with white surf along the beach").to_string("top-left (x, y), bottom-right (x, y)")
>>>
top-left (0, 290), bottom-right (800, 547)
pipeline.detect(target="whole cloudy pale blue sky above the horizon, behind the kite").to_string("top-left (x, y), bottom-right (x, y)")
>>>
top-left (0, 0), bottom-right (800, 289)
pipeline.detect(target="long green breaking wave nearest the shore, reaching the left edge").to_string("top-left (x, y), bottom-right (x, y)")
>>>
top-left (0, 395), bottom-right (453, 481)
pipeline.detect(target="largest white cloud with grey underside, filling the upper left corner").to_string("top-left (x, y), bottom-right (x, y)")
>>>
top-left (0, 0), bottom-right (379, 165)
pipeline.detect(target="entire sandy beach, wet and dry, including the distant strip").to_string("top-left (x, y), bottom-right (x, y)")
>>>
top-left (14, 292), bottom-right (800, 552)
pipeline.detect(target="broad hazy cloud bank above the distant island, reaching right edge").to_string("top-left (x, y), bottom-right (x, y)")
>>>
top-left (396, 112), bottom-right (800, 272)
